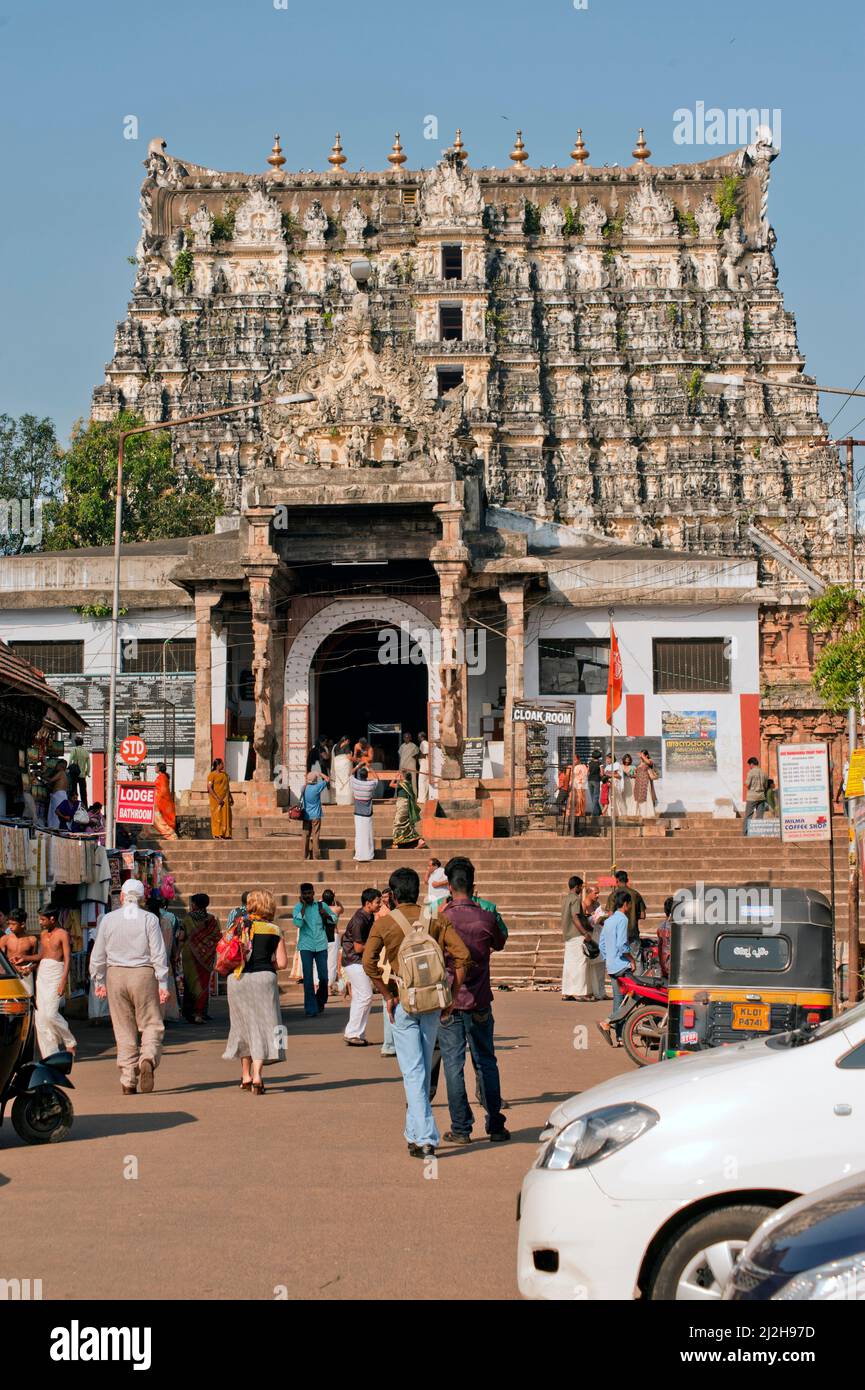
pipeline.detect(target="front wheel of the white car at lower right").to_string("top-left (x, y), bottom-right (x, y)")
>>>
top-left (647, 1205), bottom-right (775, 1302)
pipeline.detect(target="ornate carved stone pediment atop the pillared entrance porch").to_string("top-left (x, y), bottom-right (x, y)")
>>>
top-left (264, 300), bottom-right (464, 468)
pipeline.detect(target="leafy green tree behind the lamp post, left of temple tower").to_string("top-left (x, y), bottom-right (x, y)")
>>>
top-left (45, 411), bottom-right (221, 550)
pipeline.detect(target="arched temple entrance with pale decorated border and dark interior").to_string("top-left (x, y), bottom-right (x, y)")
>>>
top-left (284, 598), bottom-right (438, 794)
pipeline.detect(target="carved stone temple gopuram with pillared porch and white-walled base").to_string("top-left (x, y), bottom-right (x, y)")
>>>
top-left (0, 131), bottom-right (847, 815)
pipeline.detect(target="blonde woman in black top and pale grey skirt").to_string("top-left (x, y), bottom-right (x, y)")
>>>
top-left (223, 890), bottom-right (288, 1095)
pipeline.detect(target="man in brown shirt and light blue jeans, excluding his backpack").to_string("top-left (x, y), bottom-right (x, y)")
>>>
top-left (363, 867), bottom-right (471, 1158)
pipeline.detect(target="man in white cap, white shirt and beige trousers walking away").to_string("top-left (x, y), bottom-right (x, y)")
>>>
top-left (90, 878), bottom-right (168, 1095)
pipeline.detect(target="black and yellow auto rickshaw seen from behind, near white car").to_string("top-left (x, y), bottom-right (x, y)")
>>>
top-left (665, 884), bottom-right (834, 1058)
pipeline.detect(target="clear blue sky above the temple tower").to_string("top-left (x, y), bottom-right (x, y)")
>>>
top-left (0, 0), bottom-right (865, 439)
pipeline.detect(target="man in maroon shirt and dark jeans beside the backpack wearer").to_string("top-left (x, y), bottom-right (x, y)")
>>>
top-left (438, 859), bottom-right (510, 1144)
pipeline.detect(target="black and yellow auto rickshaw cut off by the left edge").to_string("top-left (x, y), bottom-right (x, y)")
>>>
top-left (0, 951), bottom-right (74, 1144)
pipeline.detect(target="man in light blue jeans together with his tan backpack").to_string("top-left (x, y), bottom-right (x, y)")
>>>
top-left (363, 867), bottom-right (471, 1158)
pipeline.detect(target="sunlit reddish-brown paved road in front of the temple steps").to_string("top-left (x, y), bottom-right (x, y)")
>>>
top-left (0, 991), bottom-right (631, 1298)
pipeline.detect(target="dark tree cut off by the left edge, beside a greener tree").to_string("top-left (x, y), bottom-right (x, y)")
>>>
top-left (0, 414), bottom-right (63, 555)
